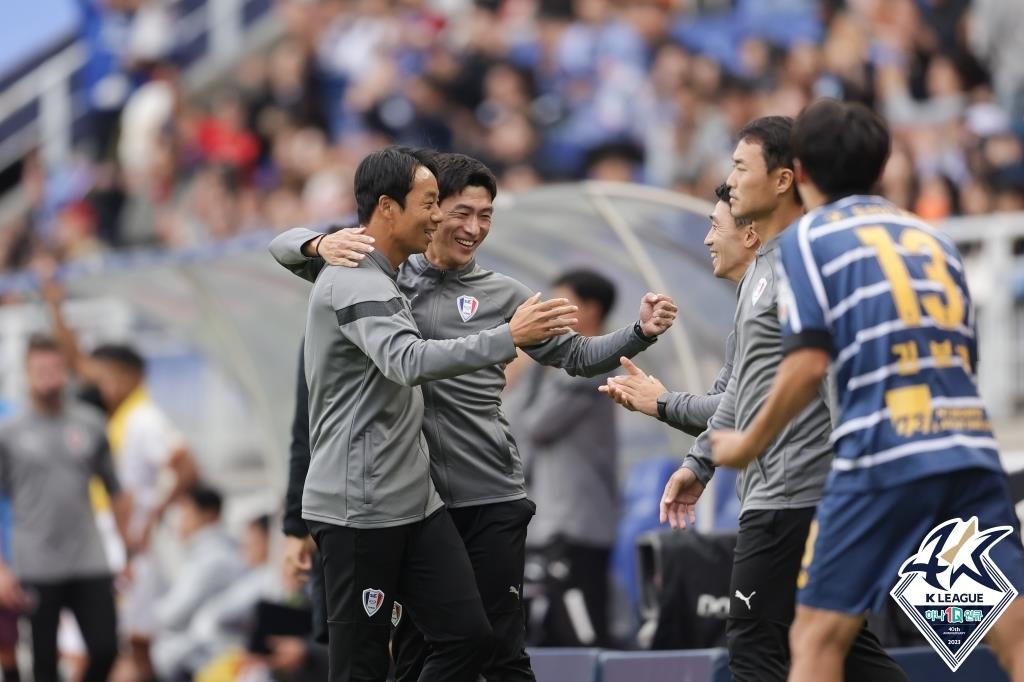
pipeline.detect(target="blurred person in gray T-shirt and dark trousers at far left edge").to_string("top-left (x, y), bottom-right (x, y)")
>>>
top-left (0, 337), bottom-right (131, 682)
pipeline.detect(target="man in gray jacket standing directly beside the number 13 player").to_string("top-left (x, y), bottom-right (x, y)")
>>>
top-left (662, 117), bottom-right (906, 682)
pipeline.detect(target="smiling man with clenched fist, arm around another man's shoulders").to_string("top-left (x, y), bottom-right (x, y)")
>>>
top-left (271, 155), bottom-right (676, 680)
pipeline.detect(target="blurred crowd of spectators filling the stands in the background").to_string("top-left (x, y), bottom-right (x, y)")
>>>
top-left (0, 0), bottom-right (1024, 270)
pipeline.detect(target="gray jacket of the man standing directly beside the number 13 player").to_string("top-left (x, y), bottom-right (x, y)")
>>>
top-left (683, 238), bottom-right (833, 513)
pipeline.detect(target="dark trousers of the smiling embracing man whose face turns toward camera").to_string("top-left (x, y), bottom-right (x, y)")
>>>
top-left (391, 499), bottom-right (537, 682)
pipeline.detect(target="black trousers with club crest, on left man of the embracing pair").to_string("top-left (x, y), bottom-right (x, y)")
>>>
top-left (308, 509), bottom-right (493, 682)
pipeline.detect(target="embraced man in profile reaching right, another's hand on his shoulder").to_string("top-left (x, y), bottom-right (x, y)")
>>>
top-left (288, 147), bottom-right (593, 682)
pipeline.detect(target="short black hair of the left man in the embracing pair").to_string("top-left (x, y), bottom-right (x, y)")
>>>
top-left (353, 146), bottom-right (437, 225)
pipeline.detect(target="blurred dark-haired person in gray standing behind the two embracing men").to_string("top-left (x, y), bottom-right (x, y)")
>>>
top-left (515, 270), bottom-right (618, 646)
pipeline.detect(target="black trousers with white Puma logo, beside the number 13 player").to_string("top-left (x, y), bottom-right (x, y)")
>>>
top-left (725, 507), bottom-right (908, 682)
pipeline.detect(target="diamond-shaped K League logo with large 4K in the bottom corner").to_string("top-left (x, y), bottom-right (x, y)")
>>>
top-left (890, 517), bottom-right (1017, 671)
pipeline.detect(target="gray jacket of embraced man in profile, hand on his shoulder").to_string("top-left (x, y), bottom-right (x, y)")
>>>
top-left (302, 251), bottom-right (516, 528)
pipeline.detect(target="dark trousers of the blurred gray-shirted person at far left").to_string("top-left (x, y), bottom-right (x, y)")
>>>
top-left (25, 576), bottom-right (118, 682)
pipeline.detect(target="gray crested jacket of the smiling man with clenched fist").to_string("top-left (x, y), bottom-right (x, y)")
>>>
top-left (270, 227), bottom-right (653, 507)
